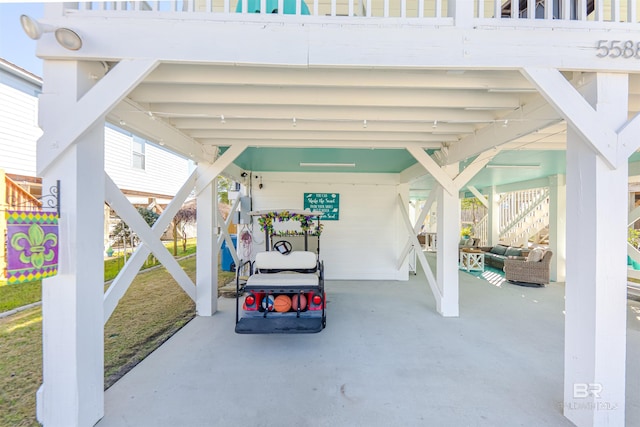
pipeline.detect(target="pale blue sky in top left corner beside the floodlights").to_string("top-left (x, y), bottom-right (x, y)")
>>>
top-left (0, 0), bottom-right (44, 77)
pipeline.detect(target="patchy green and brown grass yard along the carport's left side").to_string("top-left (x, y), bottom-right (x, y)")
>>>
top-left (0, 257), bottom-right (234, 427)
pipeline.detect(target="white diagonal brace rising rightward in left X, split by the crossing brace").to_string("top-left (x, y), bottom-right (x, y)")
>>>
top-left (104, 171), bottom-right (196, 323)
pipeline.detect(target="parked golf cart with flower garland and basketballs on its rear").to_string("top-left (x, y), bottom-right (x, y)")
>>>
top-left (235, 210), bottom-right (326, 334)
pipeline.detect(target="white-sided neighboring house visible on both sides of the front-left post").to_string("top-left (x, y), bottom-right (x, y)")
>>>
top-left (0, 58), bottom-right (193, 277)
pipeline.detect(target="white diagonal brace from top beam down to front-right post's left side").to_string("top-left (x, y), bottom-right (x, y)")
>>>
top-left (522, 68), bottom-right (618, 168)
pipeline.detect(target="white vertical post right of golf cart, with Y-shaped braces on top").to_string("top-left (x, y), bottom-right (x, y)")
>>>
top-left (436, 182), bottom-right (460, 317)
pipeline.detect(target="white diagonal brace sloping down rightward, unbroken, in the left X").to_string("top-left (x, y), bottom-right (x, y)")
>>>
top-left (105, 176), bottom-right (196, 301)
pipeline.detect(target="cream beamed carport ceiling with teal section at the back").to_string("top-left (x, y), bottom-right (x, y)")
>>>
top-left (108, 63), bottom-right (640, 186)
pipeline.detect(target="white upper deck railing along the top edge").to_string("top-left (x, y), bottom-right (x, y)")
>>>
top-left (66, 0), bottom-right (640, 23)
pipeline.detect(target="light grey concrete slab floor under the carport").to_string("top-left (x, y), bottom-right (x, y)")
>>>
top-left (97, 272), bottom-right (640, 427)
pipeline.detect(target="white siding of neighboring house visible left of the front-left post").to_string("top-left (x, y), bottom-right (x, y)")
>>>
top-left (0, 80), bottom-right (42, 176)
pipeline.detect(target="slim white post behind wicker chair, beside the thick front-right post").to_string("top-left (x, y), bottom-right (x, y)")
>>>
top-left (549, 175), bottom-right (567, 282)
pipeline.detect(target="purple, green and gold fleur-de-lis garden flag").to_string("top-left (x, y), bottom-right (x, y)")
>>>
top-left (5, 211), bottom-right (58, 284)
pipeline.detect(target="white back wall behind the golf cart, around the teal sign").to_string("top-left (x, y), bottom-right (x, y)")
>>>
top-left (253, 171), bottom-right (408, 280)
